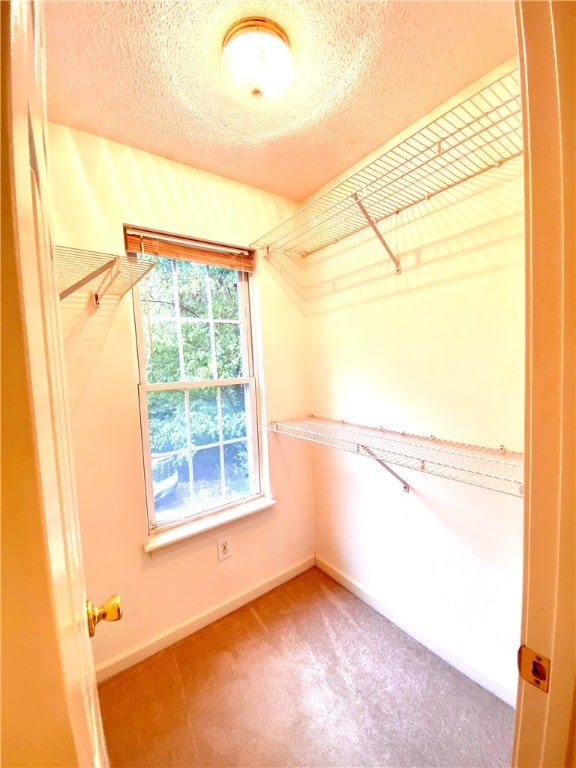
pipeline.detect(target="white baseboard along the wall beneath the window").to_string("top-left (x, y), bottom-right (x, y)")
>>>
top-left (96, 557), bottom-right (315, 683)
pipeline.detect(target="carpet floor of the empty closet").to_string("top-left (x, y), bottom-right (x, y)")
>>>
top-left (99, 568), bottom-right (514, 768)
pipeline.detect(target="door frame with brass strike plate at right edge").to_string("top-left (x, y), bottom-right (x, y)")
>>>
top-left (513, 0), bottom-right (576, 768)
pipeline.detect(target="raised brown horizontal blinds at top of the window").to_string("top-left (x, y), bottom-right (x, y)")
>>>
top-left (124, 225), bottom-right (255, 272)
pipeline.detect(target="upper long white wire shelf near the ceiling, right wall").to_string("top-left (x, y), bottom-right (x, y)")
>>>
top-left (252, 70), bottom-right (523, 264)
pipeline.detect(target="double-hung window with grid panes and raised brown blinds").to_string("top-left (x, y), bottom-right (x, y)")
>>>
top-left (125, 227), bottom-right (261, 530)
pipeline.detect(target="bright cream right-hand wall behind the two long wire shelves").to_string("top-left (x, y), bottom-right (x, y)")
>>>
top-left (305, 154), bottom-right (524, 704)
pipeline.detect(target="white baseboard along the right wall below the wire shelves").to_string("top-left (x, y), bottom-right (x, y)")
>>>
top-left (316, 557), bottom-right (516, 707)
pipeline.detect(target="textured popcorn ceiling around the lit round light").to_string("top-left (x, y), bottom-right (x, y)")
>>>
top-left (45, 0), bottom-right (516, 200)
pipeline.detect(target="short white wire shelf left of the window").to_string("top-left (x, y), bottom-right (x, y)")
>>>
top-left (54, 245), bottom-right (155, 304)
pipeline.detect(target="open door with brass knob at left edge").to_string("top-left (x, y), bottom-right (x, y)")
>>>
top-left (0, 0), bottom-right (108, 766)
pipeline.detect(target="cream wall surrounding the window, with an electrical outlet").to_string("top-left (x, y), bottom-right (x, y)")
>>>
top-left (49, 125), bottom-right (314, 676)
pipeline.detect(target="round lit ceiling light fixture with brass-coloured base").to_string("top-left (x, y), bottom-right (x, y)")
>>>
top-left (221, 17), bottom-right (294, 99)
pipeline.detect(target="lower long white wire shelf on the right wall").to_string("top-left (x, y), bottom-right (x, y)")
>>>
top-left (268, 416), bottom-right (524, 496)
